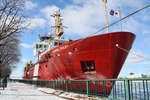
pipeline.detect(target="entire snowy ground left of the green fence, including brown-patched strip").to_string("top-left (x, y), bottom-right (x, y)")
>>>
top-left (0, 82), bottom-right (108, 100)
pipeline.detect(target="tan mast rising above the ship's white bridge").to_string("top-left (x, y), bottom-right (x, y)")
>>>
top-left (52, 9), bottom-right (64, 39)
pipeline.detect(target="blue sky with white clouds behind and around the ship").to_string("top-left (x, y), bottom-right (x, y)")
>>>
top-left (11, 0), bottom-right (150, 78)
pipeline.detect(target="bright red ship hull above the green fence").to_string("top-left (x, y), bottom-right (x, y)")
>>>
top-left (24, 32), bottom-right (135, 80)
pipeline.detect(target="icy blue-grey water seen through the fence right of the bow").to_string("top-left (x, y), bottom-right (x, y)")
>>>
top-left (109, 81), bottom-right (150, 100)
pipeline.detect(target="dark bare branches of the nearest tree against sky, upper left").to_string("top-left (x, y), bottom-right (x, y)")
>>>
top-left (0, 0), bottom-right (24, 41)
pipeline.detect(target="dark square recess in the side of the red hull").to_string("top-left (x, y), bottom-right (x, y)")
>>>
top-left (80, 60), bottom-right (95, 72)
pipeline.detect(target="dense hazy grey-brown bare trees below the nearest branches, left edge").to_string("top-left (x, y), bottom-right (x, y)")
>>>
top-left (0, 34), bottom-right (20, 75)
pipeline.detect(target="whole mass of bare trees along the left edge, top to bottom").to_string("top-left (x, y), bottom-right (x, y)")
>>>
top-left (0, 0), bottom-right (25, 76)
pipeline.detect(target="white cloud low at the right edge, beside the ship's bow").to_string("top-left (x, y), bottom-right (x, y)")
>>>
top-left (127, 50), bottom-right (150, 63)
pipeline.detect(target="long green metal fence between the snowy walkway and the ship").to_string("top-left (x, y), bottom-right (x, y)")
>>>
top-left (11, 78), bottom-right (150, 100)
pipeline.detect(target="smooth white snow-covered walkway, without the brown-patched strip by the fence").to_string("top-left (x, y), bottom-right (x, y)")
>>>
top-left (0, 83), bottom-right (66, 100)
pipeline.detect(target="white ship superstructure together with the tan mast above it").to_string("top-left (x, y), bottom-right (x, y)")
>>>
top-left (33, 10), bottom-right (67, 60)
